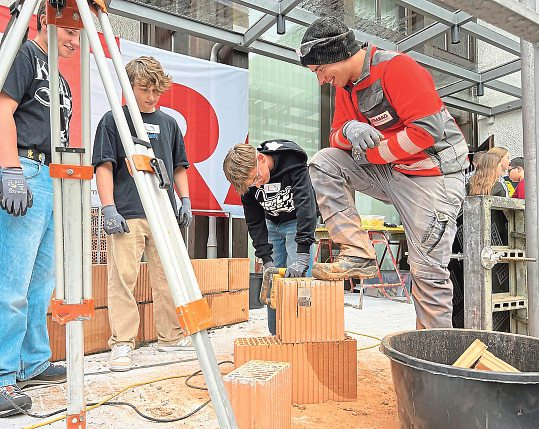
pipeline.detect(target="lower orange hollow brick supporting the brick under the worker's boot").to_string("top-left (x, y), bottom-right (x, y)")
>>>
top-left (234, 337), bottom-right (357, 404)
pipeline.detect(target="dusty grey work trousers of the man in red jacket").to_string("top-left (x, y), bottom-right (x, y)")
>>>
top-left (309, 148), bottom-right (464, 329)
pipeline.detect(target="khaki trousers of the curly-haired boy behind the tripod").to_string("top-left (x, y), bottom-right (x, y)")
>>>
top-left (107, 219), bottom-right (183, 348)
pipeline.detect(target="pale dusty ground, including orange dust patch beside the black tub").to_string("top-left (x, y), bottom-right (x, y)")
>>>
top-left (5, 294), bottom-right (415, 429)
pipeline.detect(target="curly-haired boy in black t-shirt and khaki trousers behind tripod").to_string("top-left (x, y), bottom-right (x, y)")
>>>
top-left (92, 57), bottom-right (192, 371)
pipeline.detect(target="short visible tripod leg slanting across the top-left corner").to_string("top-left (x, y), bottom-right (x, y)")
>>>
top-left (0, 0), bottom-right (39, 88)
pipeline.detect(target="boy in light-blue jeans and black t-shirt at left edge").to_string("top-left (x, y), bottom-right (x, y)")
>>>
top-left (0, 1), bottom-right (80, 417)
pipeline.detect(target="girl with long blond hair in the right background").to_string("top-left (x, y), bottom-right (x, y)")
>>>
top-left (466, 152), bottom-right (507, 197)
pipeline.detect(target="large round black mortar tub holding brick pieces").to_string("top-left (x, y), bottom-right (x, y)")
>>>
top-left (380, 329), bottom-right (539, 429)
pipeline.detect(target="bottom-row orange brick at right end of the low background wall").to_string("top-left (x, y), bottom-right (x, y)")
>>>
top-left (204, 290), bottom-right (249, 326)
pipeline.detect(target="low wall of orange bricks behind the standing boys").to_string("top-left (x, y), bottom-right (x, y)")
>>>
top-left (47, 258), bottom-right (249, 361)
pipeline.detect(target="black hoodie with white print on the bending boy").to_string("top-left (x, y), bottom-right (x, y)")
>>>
top-left (241, 140), bottom-right (317, 263)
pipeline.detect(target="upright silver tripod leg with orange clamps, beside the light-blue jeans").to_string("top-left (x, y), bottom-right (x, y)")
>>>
top-left (48, 23), bottom-right (93, 429)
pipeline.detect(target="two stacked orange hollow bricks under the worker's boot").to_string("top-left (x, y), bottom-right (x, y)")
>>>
top-left (234, 277), bottom-right (357, 406)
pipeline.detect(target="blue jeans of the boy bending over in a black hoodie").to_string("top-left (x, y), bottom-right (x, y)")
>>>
top-left (266, 220), bottom-right (313, 335)
